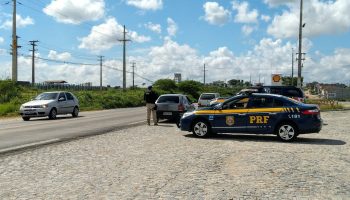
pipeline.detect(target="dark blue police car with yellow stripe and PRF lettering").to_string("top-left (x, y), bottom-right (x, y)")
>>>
top-left (180, 93), bottom-right (322, 141)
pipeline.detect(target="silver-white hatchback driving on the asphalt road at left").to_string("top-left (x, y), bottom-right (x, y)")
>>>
top-left (19, 91), bottom-right (79, 121)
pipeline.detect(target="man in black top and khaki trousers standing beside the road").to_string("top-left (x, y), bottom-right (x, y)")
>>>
top-left (143, 86), bottom-right (158, 125)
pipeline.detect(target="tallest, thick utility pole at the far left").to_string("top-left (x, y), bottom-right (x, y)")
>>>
top-left (12, 0), bottom-right (18, 82)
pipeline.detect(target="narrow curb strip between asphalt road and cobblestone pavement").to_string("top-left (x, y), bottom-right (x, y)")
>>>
top-left (0, 121), bottom-right (146, 156)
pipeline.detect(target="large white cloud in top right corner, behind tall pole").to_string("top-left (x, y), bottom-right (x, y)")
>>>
top-left (267, 0), bottom-right (350, 38)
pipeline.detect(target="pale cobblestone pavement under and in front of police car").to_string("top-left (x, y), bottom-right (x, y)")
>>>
top-left (0, 111), bottom-right (350, 199)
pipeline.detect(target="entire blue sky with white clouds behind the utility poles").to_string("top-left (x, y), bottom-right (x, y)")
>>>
top-left (0, 0), bottom-right (350, 86)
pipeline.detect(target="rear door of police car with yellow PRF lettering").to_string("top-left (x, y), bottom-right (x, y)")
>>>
top-left (247, 96), bottom-right (279, 133)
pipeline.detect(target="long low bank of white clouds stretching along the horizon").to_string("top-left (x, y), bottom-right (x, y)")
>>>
top-left (4, 38), bottom-right (350, 86)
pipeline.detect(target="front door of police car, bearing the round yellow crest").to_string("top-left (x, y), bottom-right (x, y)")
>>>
top-left (212, 97), bottom-right (249, 133)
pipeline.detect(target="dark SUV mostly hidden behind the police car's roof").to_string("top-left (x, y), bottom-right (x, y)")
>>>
top-left (239, 86), bottom-right (305, 102)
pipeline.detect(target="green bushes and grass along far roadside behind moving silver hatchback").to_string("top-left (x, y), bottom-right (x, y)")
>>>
top-left (0, 80), bottom-right (144, 117)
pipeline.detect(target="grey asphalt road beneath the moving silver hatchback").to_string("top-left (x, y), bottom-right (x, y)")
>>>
top-left (0, 107), bottom-right (146, 153)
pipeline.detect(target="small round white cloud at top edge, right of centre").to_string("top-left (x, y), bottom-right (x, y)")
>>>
top-left (203, 2), bottom-right (231, 25)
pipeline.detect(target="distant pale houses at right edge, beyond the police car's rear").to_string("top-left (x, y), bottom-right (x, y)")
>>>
top-left (316, 84), bottom-right (350, 99)
